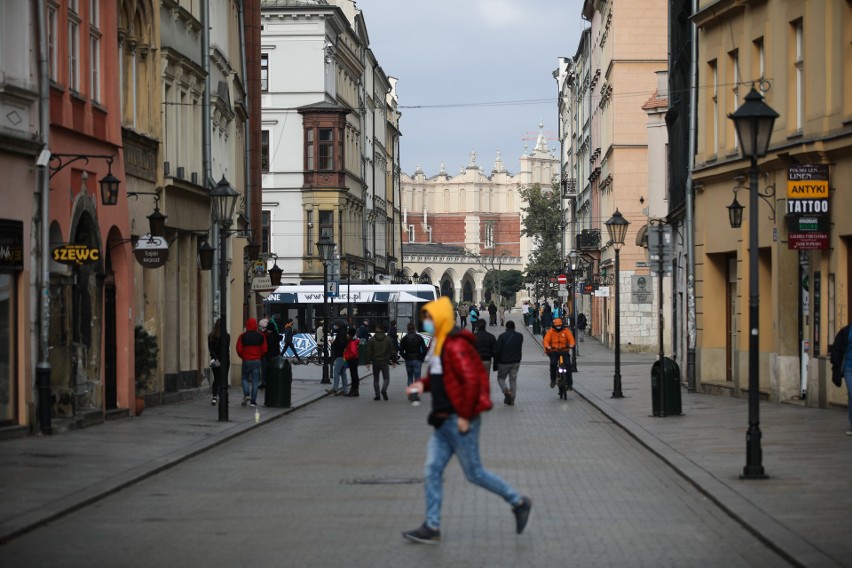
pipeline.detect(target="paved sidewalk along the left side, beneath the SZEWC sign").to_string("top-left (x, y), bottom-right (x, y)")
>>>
top-left (0, 365), bottom-right (330, 544)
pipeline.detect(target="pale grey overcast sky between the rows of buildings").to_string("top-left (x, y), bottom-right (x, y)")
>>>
top-left (356, 0), bottom-right (588, 176)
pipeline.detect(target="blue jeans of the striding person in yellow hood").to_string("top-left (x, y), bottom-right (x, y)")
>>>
top-left (424, 414), bottom-right (521, 530)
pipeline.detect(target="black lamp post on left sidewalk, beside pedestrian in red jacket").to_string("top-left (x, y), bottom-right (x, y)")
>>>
top-left (210, 175), bottom-right (240, 422)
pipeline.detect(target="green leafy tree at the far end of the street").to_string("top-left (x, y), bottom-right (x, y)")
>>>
top-left (520, 184), bottom-right (564, 296)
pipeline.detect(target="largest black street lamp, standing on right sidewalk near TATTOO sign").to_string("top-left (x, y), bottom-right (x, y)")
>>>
top-left (728, 87), bottom-right (778, 479)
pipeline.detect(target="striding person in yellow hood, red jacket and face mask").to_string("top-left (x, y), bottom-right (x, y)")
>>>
top-left (402, 297), bottom-right (532, 544)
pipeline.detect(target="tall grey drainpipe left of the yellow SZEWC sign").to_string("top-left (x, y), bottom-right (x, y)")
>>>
top-left (36, 2), bottom-right (53, 434)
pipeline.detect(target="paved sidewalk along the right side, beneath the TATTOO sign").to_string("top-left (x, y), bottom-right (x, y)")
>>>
top-left (519, 320), bottom-right (852, 567)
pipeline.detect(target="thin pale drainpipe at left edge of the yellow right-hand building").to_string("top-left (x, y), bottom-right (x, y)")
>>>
top-left (685, 0), bottom-right (698, 392)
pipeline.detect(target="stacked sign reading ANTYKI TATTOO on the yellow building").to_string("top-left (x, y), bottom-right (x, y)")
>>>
top-left (785, 164), bottom-right (829, 250)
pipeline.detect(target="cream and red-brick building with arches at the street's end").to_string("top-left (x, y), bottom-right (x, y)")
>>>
top-left (401, 131), bottom-right (559, 302)
